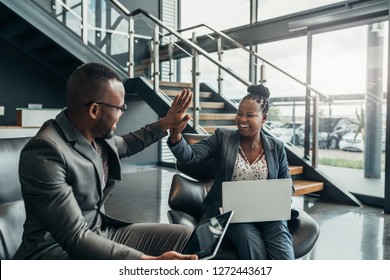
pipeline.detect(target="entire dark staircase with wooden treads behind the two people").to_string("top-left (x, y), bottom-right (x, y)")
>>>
top-left (0, 0), bottom-right (361, 209)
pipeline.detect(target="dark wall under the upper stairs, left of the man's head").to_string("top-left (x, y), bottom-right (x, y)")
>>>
top-left (0, 39), bottom-right (65, 126)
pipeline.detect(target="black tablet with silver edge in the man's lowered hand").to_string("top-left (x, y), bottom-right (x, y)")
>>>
top-left (180, 211), bottom-right (233, 260)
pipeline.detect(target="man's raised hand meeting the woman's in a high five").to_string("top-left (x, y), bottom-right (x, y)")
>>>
top-left (160, 89), bottom-right (192, 134)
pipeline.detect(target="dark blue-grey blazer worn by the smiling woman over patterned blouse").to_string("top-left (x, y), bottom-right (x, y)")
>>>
top-left (168, 129), bottom-right (290, 219)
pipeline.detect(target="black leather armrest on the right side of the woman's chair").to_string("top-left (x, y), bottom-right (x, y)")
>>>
top-left (288, 208), bottom-right (320, 259)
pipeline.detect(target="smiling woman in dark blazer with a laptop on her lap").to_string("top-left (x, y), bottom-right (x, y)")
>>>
top-left (168, 85), bottom-right (294, 259)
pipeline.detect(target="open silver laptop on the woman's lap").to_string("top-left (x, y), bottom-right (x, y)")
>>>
top-left (222, 178), bottom-right (292, 223)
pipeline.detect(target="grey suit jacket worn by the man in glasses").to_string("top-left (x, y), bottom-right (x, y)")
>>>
top-left (14, 111), bottom-right (166, 259)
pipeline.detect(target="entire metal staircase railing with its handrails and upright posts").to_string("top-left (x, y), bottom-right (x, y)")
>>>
top-left (32, 0), bottom-right (327, 167)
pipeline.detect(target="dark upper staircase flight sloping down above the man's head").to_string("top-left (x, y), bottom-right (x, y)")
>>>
top-left (0, 0), bottom-right (128, 81)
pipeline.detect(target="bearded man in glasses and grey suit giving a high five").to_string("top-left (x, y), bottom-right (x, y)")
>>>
top-left (14, 63), bottom-right (197, 259)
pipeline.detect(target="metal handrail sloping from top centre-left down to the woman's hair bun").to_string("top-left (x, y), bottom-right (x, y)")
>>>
top-left (111, 3), bottom-right (252, 86)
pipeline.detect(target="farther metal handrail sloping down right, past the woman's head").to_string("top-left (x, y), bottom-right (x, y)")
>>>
top-left (178, 23), bottom-right (329, 98)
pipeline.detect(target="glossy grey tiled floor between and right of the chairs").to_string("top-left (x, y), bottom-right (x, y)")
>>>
top-left (107, 166), bottom-right (390, 260)
